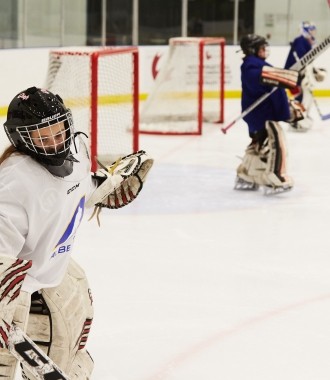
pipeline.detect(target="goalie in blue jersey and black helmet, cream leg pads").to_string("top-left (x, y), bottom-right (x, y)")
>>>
top-left (235, 34), bottom-right (302, 192)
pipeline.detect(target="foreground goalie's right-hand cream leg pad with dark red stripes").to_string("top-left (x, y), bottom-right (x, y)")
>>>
top-left (26, 259), bottom-right (93, 380)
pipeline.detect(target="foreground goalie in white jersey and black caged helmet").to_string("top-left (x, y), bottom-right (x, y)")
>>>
top-left (0, 87), bottom-right (153, 380)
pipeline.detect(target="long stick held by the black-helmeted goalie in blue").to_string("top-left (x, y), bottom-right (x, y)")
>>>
top-left (221, 36), bottom-right (330, 134)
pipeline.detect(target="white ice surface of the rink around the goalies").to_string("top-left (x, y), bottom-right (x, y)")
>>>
top-left (9, 99), bottom-right (330, 380)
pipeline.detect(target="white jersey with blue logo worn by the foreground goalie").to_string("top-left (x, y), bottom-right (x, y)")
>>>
top-left (0, 139), bottom-right (95, 293)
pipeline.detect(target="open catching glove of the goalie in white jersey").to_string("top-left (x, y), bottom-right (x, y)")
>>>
top-left (86, 150), bottom-right (154, 209)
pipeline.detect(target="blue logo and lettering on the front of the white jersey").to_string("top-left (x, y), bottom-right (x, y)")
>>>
top-left (51, 197), bottom-right (85, 258)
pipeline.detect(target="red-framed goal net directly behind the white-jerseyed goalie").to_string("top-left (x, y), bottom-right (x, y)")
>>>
top-left (46, 47), bottom-right (139, 170)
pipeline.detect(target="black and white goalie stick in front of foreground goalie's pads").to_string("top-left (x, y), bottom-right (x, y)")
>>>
top-left (8, 324), bottom-right (70, 380)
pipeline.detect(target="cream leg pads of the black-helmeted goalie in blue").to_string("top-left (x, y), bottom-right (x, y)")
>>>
top-left (237, 121), bottom-right (293, 187)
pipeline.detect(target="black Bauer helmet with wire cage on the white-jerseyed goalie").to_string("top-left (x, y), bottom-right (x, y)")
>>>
top-left (4, 87), bottom-right (73, 166)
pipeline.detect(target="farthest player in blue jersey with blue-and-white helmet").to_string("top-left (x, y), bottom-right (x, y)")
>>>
top-left (284, 21), bottom-right (326, 132)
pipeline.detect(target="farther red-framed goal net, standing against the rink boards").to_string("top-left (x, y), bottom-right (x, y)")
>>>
top-left (140, 37), bottom-right (225, 135)
